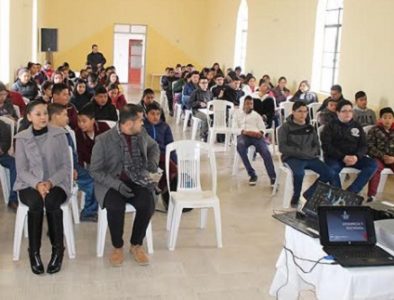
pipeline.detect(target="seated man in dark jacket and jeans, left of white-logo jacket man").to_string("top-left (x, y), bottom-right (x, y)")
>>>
top-left (278, 101), bottom-right (335, 207)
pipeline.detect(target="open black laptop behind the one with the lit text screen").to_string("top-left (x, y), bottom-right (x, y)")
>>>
top-left (273, 181), bottom-right (364, 238)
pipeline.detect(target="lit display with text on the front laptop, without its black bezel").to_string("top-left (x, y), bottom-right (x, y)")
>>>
top-left (327, 210), bottom-right (368, 242)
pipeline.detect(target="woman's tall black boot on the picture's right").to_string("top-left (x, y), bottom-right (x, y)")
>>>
top-left (47, 208), bottom-right (64, 274)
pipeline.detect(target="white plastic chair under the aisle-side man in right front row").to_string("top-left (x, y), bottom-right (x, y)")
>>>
top-left (272, 126), bottom-right (317, 208)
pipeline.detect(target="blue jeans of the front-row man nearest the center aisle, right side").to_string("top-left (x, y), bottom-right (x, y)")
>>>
top-left (284, 158), bottom-right (335, 203)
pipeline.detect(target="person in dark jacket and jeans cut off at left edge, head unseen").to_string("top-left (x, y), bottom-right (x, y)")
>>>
top-left (0, 118), bottom-right (18, 211)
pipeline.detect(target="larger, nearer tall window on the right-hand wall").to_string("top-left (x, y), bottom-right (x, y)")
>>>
top-left (312, 0), bottom-right (343, 92)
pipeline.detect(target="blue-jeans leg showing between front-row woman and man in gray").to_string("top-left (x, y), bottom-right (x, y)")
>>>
top-left (77, 167), bottom-right (98, 217)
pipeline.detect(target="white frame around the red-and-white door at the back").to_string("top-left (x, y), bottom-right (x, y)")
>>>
top-left (113, 23), bottom-right (148, 89)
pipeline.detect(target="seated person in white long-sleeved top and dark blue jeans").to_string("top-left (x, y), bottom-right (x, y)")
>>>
top-left (233, 96), bottom-right (276, 185)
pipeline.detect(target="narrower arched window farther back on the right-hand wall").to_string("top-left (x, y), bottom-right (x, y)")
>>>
top-left (234, 0), bottom-right (248, 70)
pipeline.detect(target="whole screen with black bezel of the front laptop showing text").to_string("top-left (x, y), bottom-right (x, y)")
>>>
top-left (318, 206), bottom-right (376, 246)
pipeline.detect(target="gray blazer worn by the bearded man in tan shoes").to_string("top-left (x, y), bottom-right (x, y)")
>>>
top-left (89, 126), bottom-right (160, 207)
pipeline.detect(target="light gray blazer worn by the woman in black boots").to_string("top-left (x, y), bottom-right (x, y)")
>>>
top-left (14, 126), bottom-right (72, 197)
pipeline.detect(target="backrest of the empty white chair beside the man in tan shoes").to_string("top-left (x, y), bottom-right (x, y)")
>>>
top-left (166, 140), bottom-right (217, 194)
